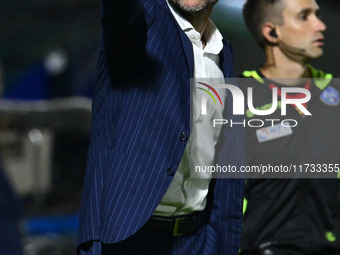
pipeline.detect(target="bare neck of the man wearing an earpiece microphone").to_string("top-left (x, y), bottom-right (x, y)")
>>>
top-left (262, 47), bottom-right (309, 85)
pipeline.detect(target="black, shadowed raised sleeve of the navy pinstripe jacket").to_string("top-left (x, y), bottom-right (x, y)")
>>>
top-left (101, 0), bottom-right (154, 83)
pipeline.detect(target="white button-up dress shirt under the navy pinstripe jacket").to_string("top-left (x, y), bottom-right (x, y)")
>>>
top-left (154, 3), bottom-right (225, 216)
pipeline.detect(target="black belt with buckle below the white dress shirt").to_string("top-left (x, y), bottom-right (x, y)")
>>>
top-left (144, 211), bottom-right (207, 237)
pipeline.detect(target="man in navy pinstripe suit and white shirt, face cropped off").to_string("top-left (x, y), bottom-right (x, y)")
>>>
top-left (78, 0), bottom-right (244, 255)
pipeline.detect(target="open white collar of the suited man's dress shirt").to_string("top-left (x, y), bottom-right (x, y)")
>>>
top-left (166, 0), bottom-right (223, 55)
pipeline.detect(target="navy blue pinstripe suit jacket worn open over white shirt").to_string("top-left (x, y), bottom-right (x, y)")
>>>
top-left (78, 0), bottom-right (243, 254)
